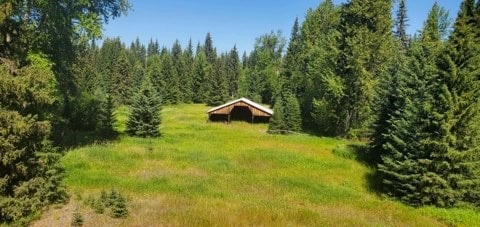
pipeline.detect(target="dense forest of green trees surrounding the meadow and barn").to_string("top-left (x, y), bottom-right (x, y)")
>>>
top-left (0, 0), bottom-right (480, 222)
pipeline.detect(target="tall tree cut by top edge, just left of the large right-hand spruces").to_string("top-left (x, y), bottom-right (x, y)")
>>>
top-left (337, 0), bottom-right (393, 136)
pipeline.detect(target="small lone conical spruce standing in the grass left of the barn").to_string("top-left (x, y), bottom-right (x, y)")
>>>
top-left (127, 77), bottom-right (161, 137)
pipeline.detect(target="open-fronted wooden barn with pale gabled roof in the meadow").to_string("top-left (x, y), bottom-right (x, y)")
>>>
top-left (207, 98), bottom-right (273, 123)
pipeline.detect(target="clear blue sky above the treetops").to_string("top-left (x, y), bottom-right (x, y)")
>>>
top-left (104, 0), bottom-right (461, 54)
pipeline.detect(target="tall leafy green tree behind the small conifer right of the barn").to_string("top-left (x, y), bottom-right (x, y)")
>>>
top-left (298, 1), bottom-right (345, 136)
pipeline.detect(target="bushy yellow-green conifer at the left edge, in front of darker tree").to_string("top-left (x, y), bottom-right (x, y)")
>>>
top-left (0, 55), bottom-right (65, 223)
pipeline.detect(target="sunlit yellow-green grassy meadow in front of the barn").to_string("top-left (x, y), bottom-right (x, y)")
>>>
top-left (62, 105), bottom-right (480, 226)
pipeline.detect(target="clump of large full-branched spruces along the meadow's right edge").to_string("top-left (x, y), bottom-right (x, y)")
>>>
top-left (373, 1), bottom-right (480, 207)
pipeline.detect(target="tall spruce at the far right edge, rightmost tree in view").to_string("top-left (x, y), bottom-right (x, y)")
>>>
top-left (434, 0), bottom-right (480, 206)
